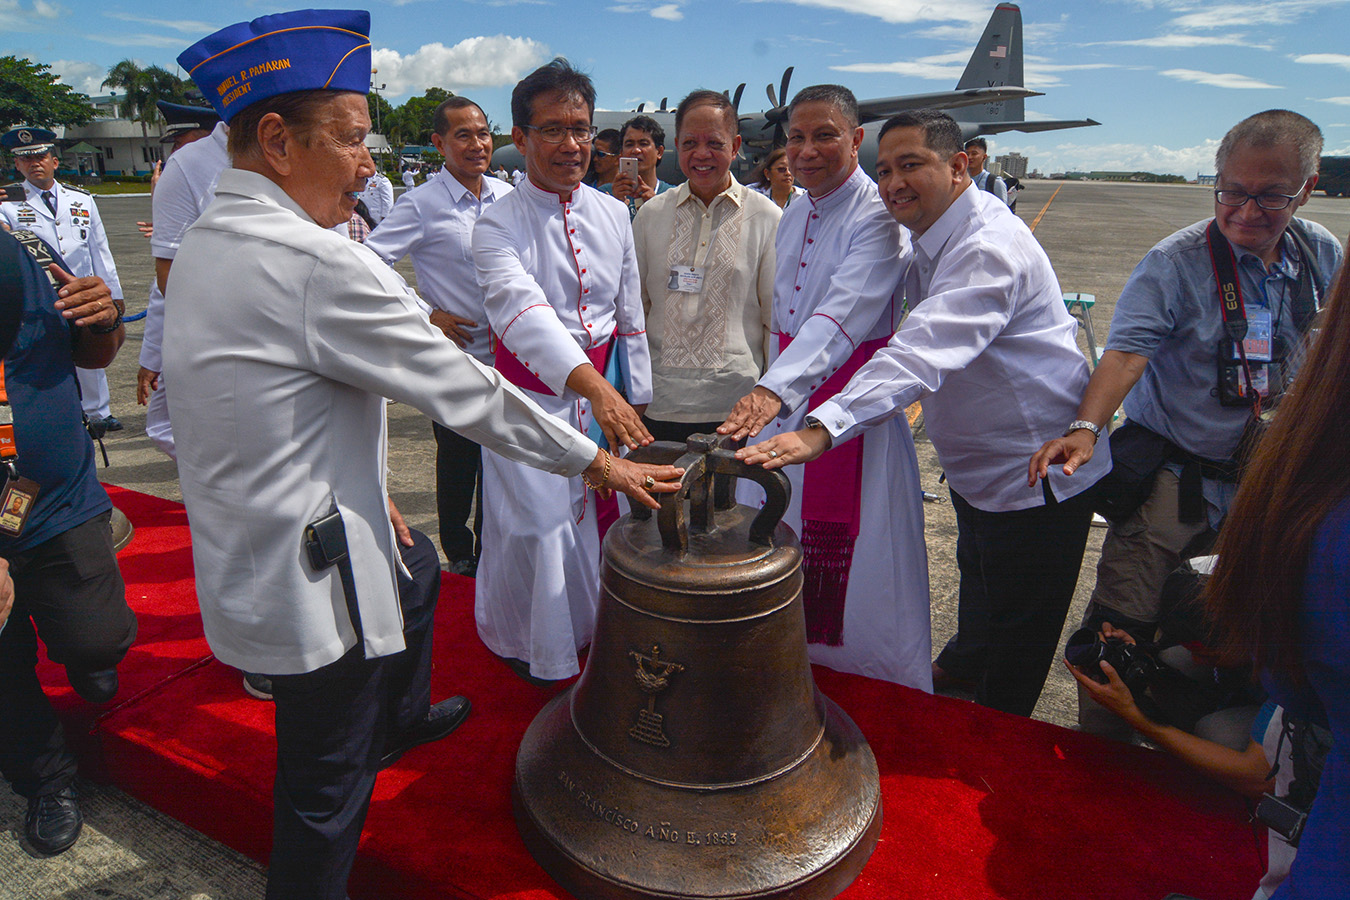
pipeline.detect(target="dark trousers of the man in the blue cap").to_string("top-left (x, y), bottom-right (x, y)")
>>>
top-left (267, 532), bottom-right (440, 900)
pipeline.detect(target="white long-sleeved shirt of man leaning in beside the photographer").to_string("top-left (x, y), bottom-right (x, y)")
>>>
top-left (815, 185), bottom-right (1111, 513)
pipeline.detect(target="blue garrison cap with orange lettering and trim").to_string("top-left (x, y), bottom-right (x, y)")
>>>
top-left (178, 9), bottom-right (370, 123)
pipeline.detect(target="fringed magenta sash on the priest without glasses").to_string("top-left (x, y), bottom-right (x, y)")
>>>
top-left (778, 333), bottom-right (887, 646)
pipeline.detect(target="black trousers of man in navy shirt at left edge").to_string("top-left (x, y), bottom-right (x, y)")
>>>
top-left (0, 513), bottom-right (136, 797)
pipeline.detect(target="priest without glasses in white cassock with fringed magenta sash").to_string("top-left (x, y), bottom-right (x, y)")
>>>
top-left (718, 85), bottom-right (933, 691)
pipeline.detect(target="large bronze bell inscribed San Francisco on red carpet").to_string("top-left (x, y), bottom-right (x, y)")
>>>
top-left (514, 434), bottom-right (882, 900)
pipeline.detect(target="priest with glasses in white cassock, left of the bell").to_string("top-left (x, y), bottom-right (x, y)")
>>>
top-left (474, 59), bottom-right (652, 680)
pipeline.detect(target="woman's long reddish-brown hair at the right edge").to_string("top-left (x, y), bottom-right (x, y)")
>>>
top-left (1206, 238), bottom-right (1350, 683)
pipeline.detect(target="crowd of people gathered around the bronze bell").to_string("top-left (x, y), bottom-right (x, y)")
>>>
top-left (0, 11), bottom-right (1350, 900)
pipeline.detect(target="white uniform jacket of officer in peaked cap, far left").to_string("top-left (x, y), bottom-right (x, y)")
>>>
top-left (0, 181), bottom-right (122, 300)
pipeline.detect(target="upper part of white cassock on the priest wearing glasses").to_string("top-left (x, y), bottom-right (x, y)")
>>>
top-left (474, 178), bottom-right (652, 403)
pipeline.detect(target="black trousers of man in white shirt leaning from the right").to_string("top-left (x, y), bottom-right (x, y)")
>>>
top-left (937, 482), bottom-right (1092, 715)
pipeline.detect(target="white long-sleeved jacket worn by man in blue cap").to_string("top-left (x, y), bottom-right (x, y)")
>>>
top-left (165, 169), bottom-right (597, 675)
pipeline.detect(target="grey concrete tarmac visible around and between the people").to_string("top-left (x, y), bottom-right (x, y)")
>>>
top-left (0, 181), bottom-right (1350, 900)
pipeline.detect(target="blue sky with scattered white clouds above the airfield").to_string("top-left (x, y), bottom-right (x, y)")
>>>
top-left (0, 0), bottom-right (1350, 177)
